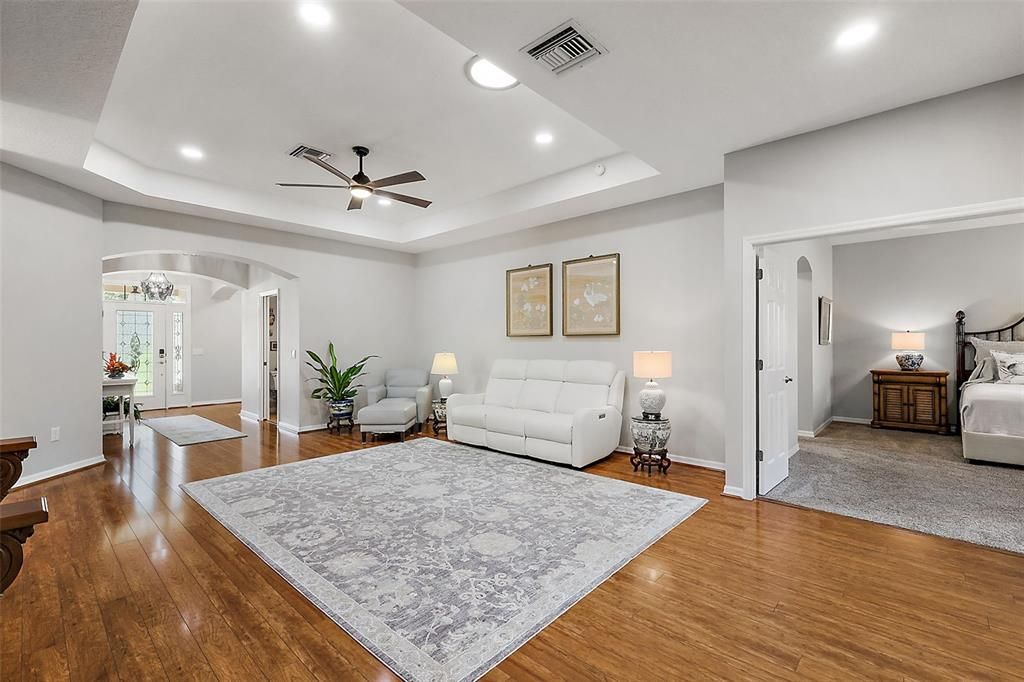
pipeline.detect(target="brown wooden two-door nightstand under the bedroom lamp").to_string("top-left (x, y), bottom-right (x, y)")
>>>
top-left (871, 370), bottom-right (949, 434)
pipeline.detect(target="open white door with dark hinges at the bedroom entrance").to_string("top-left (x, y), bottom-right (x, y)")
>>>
top-left (758, 248), bottom-right (793, 495)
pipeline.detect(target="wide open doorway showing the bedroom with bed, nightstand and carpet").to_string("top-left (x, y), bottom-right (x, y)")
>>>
top-left (758, 216), bottom-right (1024, 553)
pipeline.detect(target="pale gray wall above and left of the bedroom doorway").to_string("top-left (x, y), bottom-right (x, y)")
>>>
top-left (724, 77), bottom-right (1024, 497)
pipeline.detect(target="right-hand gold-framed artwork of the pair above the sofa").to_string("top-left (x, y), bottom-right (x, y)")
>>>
top-left (562, 253), bottom-right (620, 336)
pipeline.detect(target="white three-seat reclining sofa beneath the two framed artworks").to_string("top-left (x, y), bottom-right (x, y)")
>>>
top-left (447, 359), bottom-right (626, 468)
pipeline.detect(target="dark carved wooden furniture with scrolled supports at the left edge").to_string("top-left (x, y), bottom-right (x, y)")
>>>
top-left (0, 437), bottom-right (49, 595)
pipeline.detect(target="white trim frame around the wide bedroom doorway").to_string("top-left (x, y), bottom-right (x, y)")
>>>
top-left (741, 197), bottom-right (1024, 500)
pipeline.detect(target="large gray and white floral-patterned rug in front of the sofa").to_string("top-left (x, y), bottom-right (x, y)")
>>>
top-left (181, 438), bottom-right (707, 682)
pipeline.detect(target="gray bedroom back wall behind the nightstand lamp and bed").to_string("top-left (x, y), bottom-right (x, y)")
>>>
top-left (835, 224), bottom-right (1024, 423)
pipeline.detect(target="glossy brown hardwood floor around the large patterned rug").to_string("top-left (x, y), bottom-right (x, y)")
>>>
top-left (0, 404), bottom-right (1024, 682)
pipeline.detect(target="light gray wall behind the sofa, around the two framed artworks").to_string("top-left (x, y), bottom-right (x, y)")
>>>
top-left (416, 185), bottom-right (724, 463)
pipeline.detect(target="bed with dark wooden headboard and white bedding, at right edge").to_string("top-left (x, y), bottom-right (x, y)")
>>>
top-left (955, 310), bottom-right (1024, 466)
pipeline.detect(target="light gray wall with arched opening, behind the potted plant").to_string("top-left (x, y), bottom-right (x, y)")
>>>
top-left (97, 203), bottom-right (416, 429)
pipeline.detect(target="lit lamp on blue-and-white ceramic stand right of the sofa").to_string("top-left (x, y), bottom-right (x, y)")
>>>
top-left (630, 350), bottom-right (672, 474)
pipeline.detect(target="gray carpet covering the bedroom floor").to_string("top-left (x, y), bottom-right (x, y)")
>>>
top-left (766, 423), bottom-right (1024, 553)
